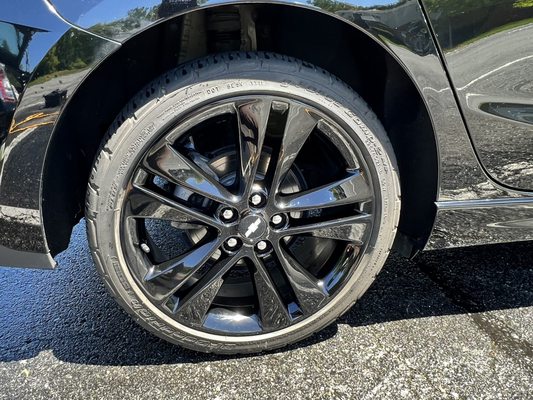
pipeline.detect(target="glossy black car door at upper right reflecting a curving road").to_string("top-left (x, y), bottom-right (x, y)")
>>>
top-left (421, 0), bottom-right (533, 190)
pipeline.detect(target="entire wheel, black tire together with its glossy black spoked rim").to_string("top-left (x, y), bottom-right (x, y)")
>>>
top-left (86, 52), bottom-right (400, 354)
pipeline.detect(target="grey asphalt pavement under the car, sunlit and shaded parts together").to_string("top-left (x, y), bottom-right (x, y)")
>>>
top-left (0, 223), bottom-right (533, 400)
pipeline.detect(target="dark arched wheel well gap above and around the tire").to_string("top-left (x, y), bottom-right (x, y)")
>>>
top-left (42, 4), bottom-right (438, 255)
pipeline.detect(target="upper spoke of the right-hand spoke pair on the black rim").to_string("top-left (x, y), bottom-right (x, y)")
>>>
top-left (279, 170), bottom-right (372, 212)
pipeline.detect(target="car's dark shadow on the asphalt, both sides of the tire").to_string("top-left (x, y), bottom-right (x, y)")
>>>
top-left (0, 224), bottom-right (533, 365)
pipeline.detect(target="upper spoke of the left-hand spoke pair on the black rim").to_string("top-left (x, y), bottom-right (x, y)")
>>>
top-left (144, 143), bottom-right (236, 205)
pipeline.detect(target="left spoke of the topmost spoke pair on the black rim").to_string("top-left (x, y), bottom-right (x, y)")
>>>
top-left (235, 100), bottom-right (270, 197)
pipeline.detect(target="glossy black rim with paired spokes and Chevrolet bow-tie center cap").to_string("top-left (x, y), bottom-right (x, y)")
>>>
top-left (120, 95), bottom-right (377, 337)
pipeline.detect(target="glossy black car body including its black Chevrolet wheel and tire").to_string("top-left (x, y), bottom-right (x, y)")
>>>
top-left (0, 0), bottom-right (533, 353)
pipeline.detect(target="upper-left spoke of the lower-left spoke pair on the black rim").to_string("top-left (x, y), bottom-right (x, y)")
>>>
top-left (144, 238), bottom-right (221, 300)
